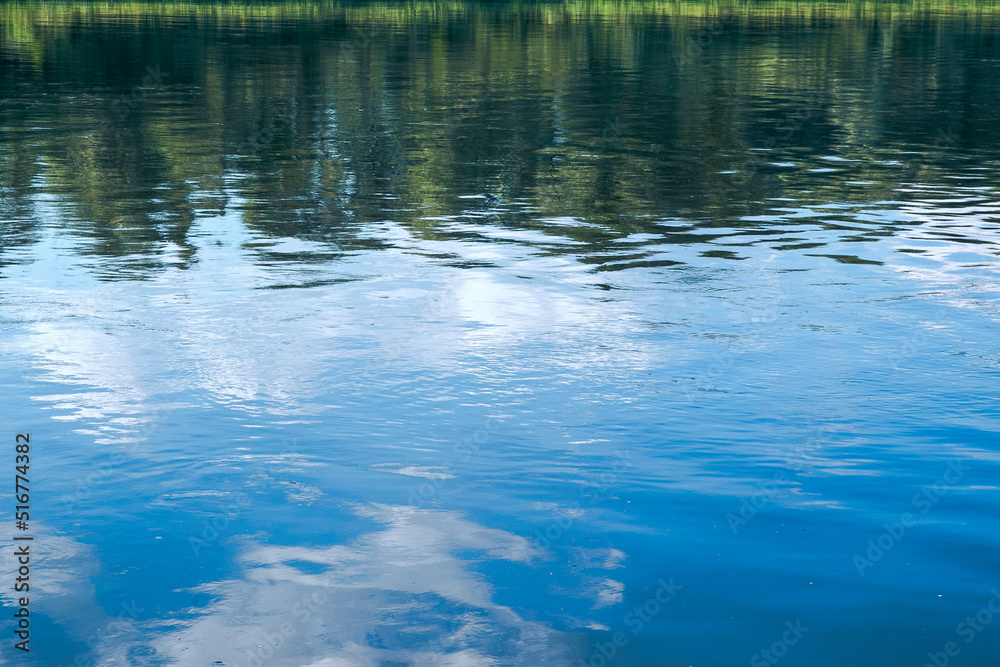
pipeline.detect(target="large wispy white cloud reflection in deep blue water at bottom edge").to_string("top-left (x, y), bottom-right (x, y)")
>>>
top-left (141, 505), bottom-right (570, 667)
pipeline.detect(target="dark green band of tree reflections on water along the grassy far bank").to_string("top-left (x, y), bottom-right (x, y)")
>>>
top-left (0, 0), bottom-right (1000, 276)
